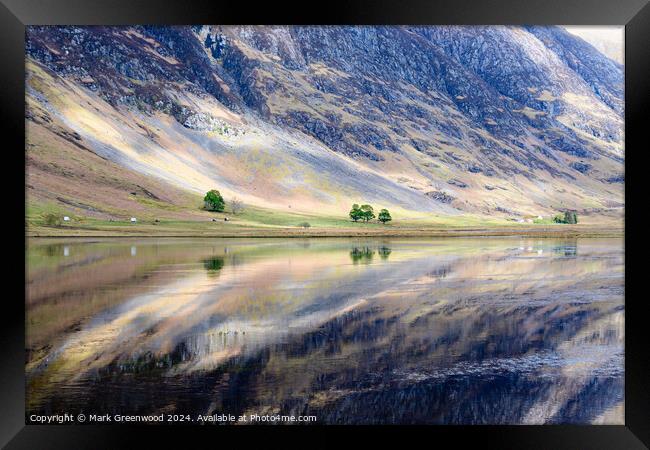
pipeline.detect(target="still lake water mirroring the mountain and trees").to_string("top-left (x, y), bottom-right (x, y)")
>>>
top-left (25, 238), bottom-right (625, 424)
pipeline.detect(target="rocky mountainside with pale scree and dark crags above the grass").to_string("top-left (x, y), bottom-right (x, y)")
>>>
top-left (26, 26), bottom-right (624, 221)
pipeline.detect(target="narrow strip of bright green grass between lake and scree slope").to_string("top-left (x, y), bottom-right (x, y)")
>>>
top-left (26, 199), bottom-right (624, 237)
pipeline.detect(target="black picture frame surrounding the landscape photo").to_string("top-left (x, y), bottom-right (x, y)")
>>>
top-left (0, 0), bottom-right (650, 449)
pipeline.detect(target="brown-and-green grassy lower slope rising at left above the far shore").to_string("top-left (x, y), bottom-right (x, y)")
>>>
top-left (26, 115), bottom-right (620, 236)
